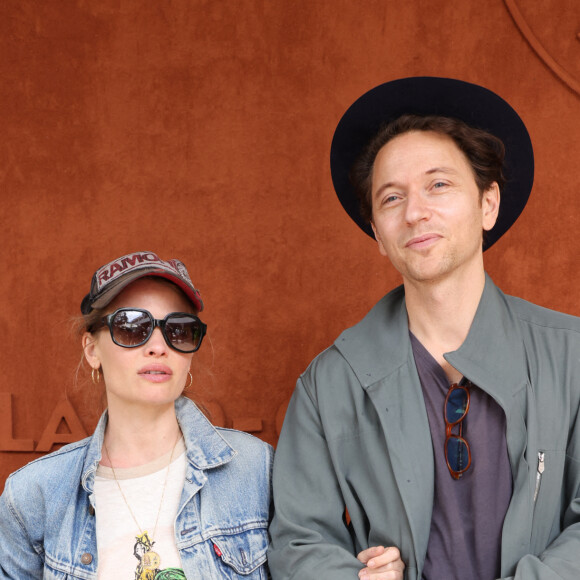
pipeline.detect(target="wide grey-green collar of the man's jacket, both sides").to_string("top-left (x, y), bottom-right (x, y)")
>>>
top-left (334, 274), bottom-right (527, 401)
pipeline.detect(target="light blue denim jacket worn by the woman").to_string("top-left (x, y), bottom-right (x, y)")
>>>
top-left (0, 397), bottom-right (272, 580)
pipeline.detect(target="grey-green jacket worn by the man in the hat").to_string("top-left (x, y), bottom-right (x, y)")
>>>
top-left (269, 278), bottom-right (580, 580)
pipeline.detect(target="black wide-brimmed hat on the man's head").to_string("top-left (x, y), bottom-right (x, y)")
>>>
top-left (330, 77), bottom-right (534, 250)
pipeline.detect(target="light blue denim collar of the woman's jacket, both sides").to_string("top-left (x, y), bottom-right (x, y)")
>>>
top-left (82, 397), bottom-right (237, 493)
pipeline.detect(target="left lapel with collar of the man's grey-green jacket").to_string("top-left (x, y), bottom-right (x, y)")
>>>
top-left (335, 287), bottom-right (434, 562)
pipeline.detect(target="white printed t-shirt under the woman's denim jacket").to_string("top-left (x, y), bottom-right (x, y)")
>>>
top-left (95, 439), bottom-right (186, 580)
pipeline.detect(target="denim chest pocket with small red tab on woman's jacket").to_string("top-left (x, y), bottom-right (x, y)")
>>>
top-left (210, 528), bottom-right (268, 580)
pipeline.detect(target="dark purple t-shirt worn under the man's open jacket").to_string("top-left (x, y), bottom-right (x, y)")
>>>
top-left (409, 333), bottom-right (512, 580)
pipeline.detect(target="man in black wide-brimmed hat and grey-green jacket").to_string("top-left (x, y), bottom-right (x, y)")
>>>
top-left (269, 77), bottom-right (580, 580)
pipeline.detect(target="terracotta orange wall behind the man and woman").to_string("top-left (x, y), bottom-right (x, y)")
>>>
top-left (0, 0), bottom-right (580, 489)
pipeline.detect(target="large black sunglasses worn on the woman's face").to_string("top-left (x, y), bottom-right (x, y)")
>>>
top-left (95, 308), bottom-right (207, 352)
